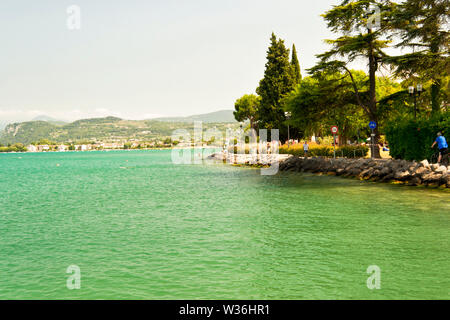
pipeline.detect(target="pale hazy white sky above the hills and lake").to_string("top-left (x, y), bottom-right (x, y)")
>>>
top-left (0, 0), bottom-right (339, 122)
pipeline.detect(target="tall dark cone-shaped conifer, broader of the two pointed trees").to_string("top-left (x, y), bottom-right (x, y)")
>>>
top-left (256, 33), bottom-right (295, 137)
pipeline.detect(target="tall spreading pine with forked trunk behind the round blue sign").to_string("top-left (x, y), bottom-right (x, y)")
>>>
top-left (309, 0), bottom-right (392, 158)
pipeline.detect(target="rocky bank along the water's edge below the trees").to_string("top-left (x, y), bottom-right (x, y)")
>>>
top-left (211, 153), bottom-right (450, 188)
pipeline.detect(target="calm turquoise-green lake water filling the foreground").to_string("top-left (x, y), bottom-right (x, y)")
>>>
top-left (0, 151), bottom-right (450, 299)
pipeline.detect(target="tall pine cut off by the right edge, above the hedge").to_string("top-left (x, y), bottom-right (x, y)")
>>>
top-left (386, 0), bottom-right (450, 113)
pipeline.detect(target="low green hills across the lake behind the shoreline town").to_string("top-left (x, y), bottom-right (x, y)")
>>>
top-left (0, 115), bottom-right (238, 144)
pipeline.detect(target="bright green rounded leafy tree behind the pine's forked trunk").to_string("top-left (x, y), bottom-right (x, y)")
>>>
top-left (284, 70), bottom-right (402, 141)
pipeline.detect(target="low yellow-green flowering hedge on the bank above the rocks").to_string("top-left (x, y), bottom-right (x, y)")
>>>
top-left (280, 145), bottom-right (369, 158)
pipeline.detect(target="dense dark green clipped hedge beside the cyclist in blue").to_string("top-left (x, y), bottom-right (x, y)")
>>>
top-left (385, 112), bottom-right (450, 161)
